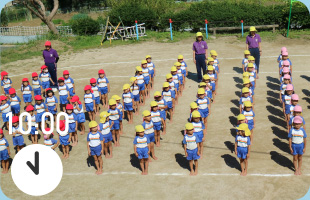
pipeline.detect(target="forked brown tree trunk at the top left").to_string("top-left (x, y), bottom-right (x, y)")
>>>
top-left (18, 0), bottom-right (59, 35)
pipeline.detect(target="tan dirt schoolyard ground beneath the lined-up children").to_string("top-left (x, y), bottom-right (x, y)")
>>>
top-left (1, 37), bottom-right (310, 199)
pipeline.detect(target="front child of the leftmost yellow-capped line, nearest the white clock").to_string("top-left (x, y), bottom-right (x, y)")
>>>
top-left (87, 121), bottom-right (104, 175)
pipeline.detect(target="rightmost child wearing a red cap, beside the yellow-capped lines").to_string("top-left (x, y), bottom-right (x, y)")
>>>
top-left (97, 69), bottom-right (110, 108)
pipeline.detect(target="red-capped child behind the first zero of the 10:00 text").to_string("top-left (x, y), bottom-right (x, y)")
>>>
top-left (12, 116), bottom-right (25, 152)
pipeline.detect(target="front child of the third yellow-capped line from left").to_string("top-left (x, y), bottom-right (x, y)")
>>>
top-left (182, 123), bottom-right (200, 176)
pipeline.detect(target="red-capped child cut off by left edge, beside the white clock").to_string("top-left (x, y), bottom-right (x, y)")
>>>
top-left (0, 128), bottom-right (11, 174)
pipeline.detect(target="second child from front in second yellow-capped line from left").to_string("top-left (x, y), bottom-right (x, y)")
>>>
top-left (142, 110), bottom-right (160, 162)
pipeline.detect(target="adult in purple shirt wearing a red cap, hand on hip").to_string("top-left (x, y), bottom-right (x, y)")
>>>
top-left (43, 41), bottom-right (59, 88)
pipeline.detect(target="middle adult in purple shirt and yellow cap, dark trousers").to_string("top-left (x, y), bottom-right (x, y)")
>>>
top-left (193, 32), bottom-right (208, 82)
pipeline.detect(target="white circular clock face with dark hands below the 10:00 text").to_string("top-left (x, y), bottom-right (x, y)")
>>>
top-left (11, 144), bottom-right (63, 196)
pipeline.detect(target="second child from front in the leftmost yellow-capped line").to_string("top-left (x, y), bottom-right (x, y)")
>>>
top-left (99, 111), bottom-right (114, 158)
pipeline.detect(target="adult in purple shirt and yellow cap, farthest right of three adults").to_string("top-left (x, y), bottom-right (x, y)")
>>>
top-left (246, 26), bottom-right (262, 73)
